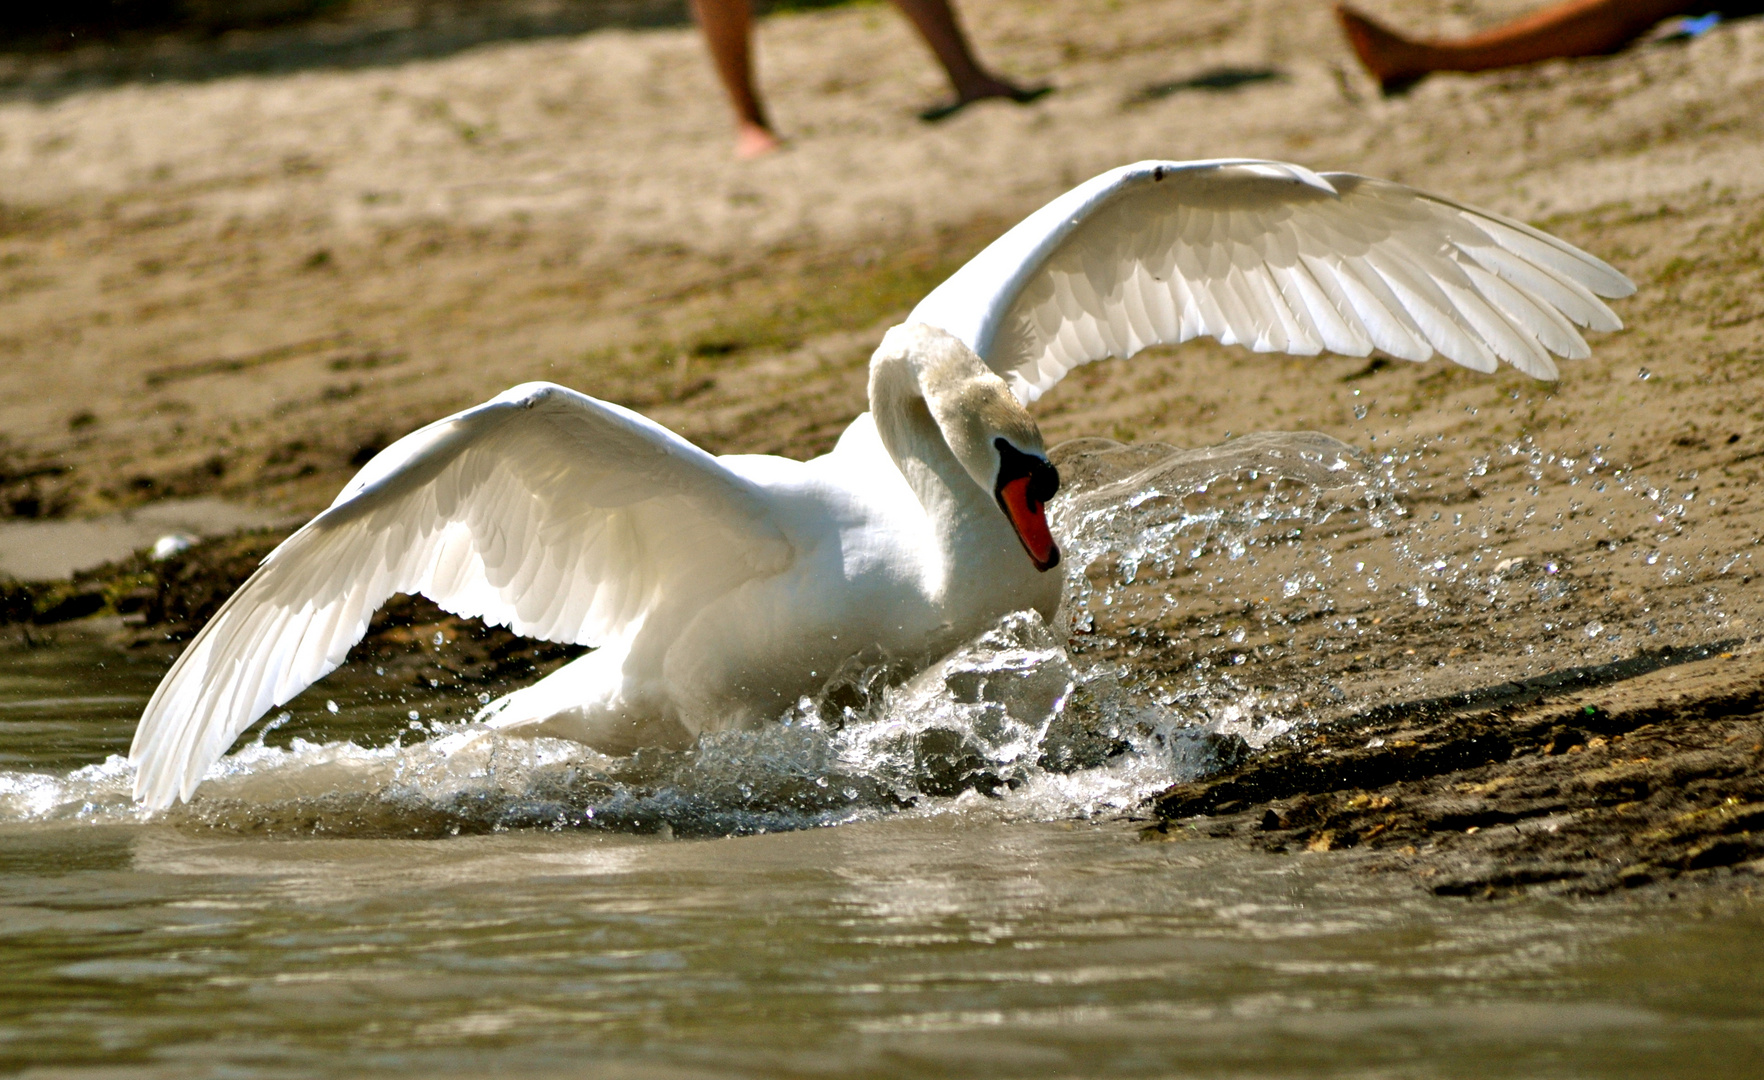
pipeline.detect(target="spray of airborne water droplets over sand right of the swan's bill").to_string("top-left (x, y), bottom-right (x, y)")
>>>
top-left (1053, 421), bottom-right (1764, 745)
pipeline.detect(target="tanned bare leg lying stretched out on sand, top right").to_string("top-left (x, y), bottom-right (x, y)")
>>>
top-left (1335, 0), bottom-right (1708, 94)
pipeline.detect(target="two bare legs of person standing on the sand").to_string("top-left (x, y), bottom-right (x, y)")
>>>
top-left (691, 0), bottom-right (1048, 157)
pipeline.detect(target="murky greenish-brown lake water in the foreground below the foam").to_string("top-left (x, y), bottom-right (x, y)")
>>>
top-left (0, 644), bottom-right (1764, 1080)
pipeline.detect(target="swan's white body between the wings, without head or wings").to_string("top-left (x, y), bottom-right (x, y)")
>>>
top-left (469, 367), bottom-right (1060, 752)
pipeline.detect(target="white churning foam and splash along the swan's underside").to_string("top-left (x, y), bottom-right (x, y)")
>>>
top-left (0, 612), bottom-right (1235, 836)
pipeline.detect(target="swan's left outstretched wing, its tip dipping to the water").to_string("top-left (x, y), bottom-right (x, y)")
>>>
top-left (129, 383), bottom-right (792, 808)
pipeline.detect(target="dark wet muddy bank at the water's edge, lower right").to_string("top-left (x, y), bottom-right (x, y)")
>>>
top-left (1145, 642), bottom-right (1764, 898)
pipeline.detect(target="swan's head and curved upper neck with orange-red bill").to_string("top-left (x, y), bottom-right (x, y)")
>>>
top-left (871, 325), bottom-right (1060, 570)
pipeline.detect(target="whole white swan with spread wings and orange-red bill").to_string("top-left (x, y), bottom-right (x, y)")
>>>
top-left (131, 161), bottom-right (1633, 806)
